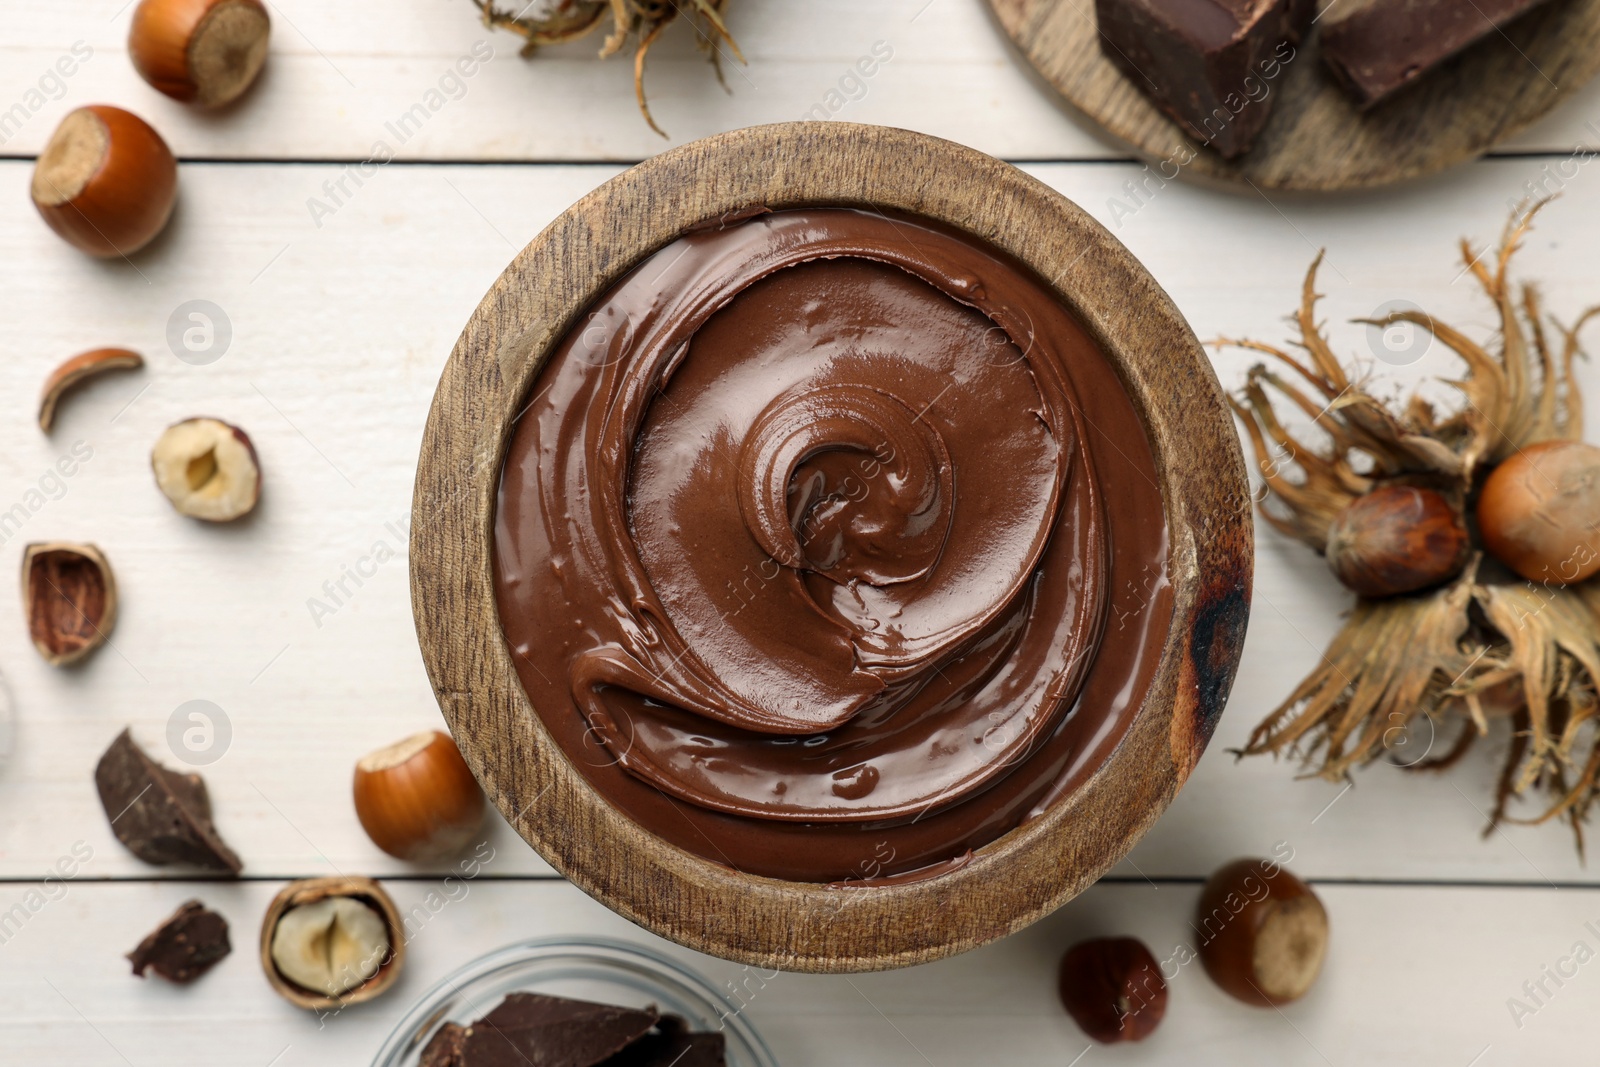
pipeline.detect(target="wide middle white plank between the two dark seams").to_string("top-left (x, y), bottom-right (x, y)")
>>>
top-left (0, 160), bottom-right (1600, 885)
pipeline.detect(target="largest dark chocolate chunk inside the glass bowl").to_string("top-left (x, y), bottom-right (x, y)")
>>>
top-left (460, 993), bottom-right (661, 1067)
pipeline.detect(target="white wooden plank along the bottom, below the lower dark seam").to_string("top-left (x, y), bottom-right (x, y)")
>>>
top-left (0, 880), bottom-right (1600, 1067)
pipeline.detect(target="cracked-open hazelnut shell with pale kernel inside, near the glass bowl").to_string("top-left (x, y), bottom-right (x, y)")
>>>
top-left (261, 877), bottom-right (405, 1011)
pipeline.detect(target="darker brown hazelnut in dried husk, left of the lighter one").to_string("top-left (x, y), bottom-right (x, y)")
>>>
top-left (1326, 485), bottom-right (1472, 597)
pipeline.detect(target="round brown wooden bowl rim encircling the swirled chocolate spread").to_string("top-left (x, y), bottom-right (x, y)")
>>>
top-left (411, 122), bottom-right (1253, 971)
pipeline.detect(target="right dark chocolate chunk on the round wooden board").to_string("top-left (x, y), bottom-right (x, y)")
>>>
top-left (1322, 0), bottom-right (1546, 109)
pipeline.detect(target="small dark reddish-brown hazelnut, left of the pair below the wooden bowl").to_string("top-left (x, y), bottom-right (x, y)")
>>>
top-left (1059, 937), bottom-right (1166, 1045)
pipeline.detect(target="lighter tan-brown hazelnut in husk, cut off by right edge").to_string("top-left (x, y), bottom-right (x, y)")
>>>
top-left (1478, 442), bottom-right (1600, 585)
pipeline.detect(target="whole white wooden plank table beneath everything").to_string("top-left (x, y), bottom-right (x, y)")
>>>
top-left (0, 0), bottom-right (1600, 1067)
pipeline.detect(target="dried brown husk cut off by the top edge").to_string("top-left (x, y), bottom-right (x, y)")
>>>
top-left (472, 0), bottom-right (744, 138)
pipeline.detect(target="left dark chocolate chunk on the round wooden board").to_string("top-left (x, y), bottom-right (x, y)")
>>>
top-left (1094, 0), bottom-right (1314, 158)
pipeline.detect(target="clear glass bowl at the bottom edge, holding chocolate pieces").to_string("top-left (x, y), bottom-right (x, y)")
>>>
top-left (373, 937), bottom-right (778, 1067)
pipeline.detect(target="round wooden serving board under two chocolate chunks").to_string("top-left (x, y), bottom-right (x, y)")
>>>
top-left (987, 0), bottom-right (1600, 192)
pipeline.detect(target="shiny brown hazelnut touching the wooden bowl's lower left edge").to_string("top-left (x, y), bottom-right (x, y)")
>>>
top-left (355, 729), bottom-right (483, 862)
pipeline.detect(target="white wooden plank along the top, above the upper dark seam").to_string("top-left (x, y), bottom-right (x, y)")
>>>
top-left (0, 0), bottom-right (1600, 160)
